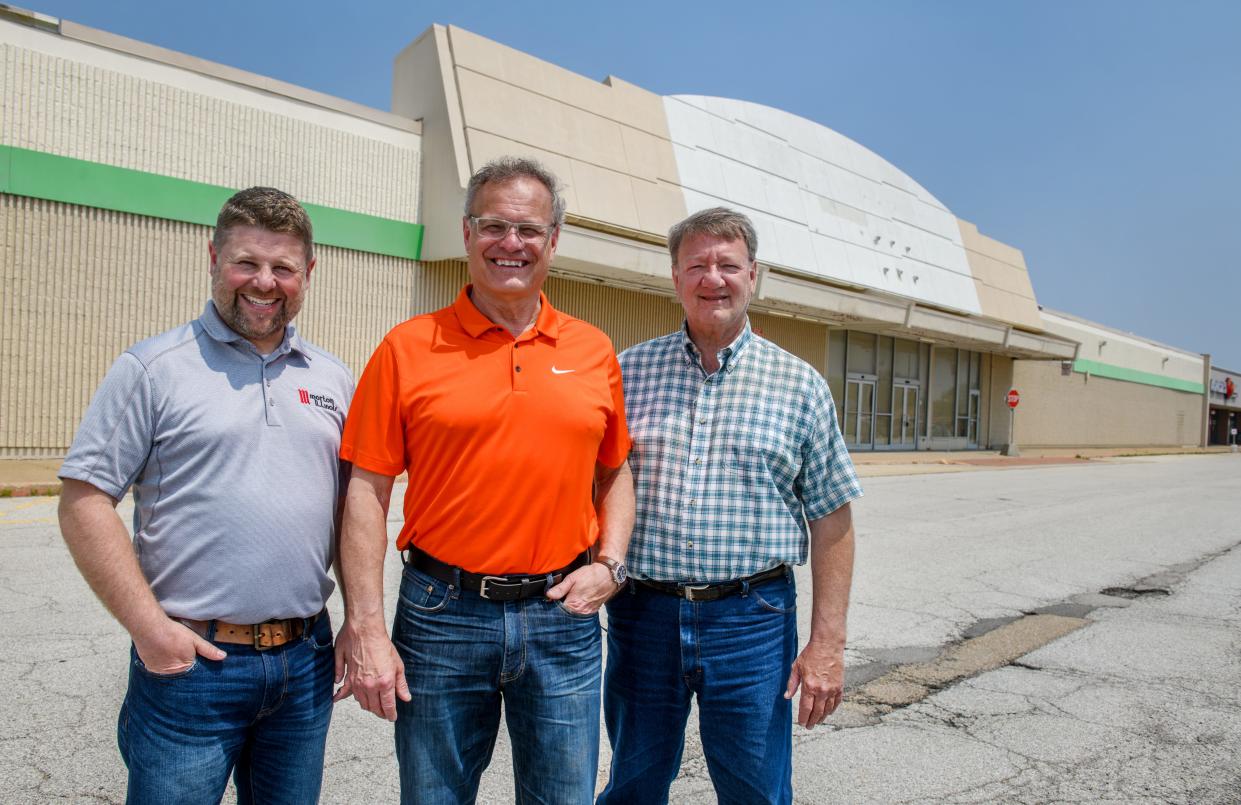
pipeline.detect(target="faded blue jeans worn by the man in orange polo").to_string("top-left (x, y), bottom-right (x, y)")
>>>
top-left (392, 566), bottom-right (602, 805)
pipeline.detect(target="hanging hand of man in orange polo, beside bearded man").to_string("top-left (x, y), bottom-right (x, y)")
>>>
top-left (331, 616), bottom-right (411, 721)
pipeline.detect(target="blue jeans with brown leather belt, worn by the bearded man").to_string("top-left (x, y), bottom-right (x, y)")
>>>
top-left (117, 613), bottom-right (334, 805)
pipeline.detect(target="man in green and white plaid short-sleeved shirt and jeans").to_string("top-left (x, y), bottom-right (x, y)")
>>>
top-left (598, 207), bottom-right (861, 805)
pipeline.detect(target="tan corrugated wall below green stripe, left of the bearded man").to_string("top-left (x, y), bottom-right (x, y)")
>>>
top-left (0, 195), bottom-right (210, 455)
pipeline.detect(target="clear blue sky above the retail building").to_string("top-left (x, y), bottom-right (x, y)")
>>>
top-left (29, 0), bottom-right (1241, 371)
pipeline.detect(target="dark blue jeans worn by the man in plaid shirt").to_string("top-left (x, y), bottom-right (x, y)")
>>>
top-left (598, 572), bottom-right (797, 805)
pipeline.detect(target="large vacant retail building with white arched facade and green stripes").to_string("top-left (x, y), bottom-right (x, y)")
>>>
top-left (0, 7), bottom-right (1215, 458)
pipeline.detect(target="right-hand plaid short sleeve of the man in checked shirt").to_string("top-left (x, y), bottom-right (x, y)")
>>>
top-left (794, 373), bottom-right (862, 520)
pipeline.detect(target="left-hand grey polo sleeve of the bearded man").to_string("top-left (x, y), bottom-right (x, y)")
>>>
top-left (58, 352), bottom-right (155, 500)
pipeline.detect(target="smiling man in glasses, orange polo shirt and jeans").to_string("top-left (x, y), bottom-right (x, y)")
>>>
top-left (336, 153), bottom-right (634, 803)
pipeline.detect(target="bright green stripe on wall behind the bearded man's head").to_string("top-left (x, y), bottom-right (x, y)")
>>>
top-left (0, 145), bottom-right (422, 260)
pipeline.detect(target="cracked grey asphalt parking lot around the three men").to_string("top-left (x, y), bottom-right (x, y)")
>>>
top-left (0, 454), bottom-right (1241, 804)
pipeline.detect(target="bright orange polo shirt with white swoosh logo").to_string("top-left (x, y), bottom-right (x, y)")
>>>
top-left (340, 285), bottom-right (630, 573)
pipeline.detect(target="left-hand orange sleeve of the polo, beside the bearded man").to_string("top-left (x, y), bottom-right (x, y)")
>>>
top-left (340, 339), bottom-right (405, 476)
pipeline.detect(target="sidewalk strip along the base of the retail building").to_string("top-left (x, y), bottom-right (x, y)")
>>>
top-left (0, 447), bottom-right (1230, 497)
